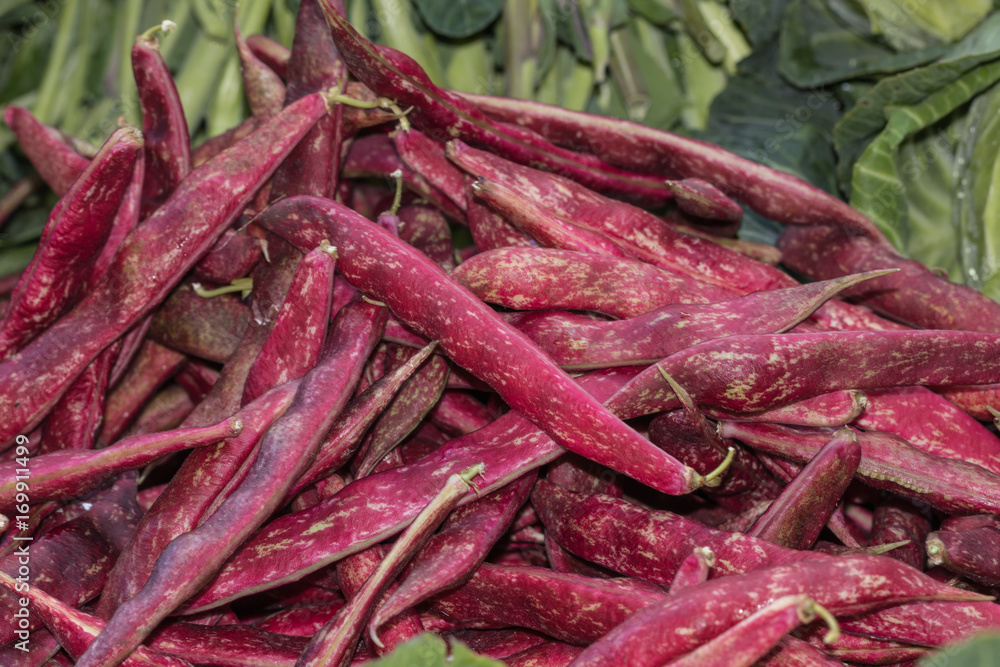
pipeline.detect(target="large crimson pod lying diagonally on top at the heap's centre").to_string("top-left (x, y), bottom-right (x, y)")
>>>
top-left (258, 197), bottom-right (703, 494)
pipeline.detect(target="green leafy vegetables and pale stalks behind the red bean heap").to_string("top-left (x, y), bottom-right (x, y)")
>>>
top-left (0, 0), bottom-right (1000, 298)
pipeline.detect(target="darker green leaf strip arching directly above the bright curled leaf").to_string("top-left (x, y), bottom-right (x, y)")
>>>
top-left (834, 14), bottom-right (1000, 191)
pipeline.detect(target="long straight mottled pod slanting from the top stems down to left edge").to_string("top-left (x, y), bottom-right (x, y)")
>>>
top-left (0, 90), bottom-right (326, 442)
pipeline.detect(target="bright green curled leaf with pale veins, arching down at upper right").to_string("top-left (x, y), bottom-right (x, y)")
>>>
top-left (851, 61), bottom-right (1000, 252)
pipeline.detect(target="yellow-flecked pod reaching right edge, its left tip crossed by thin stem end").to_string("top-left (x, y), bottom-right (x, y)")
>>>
top-left (608, 331), bottom-right (1000, 419)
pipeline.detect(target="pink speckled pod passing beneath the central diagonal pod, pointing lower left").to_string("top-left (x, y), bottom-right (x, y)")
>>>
top-left (177, 371), bottom-right (630, 613)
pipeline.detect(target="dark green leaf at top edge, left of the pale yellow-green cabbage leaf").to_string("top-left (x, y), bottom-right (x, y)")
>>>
top-left (780, 0), bottom-right (948, 88)
